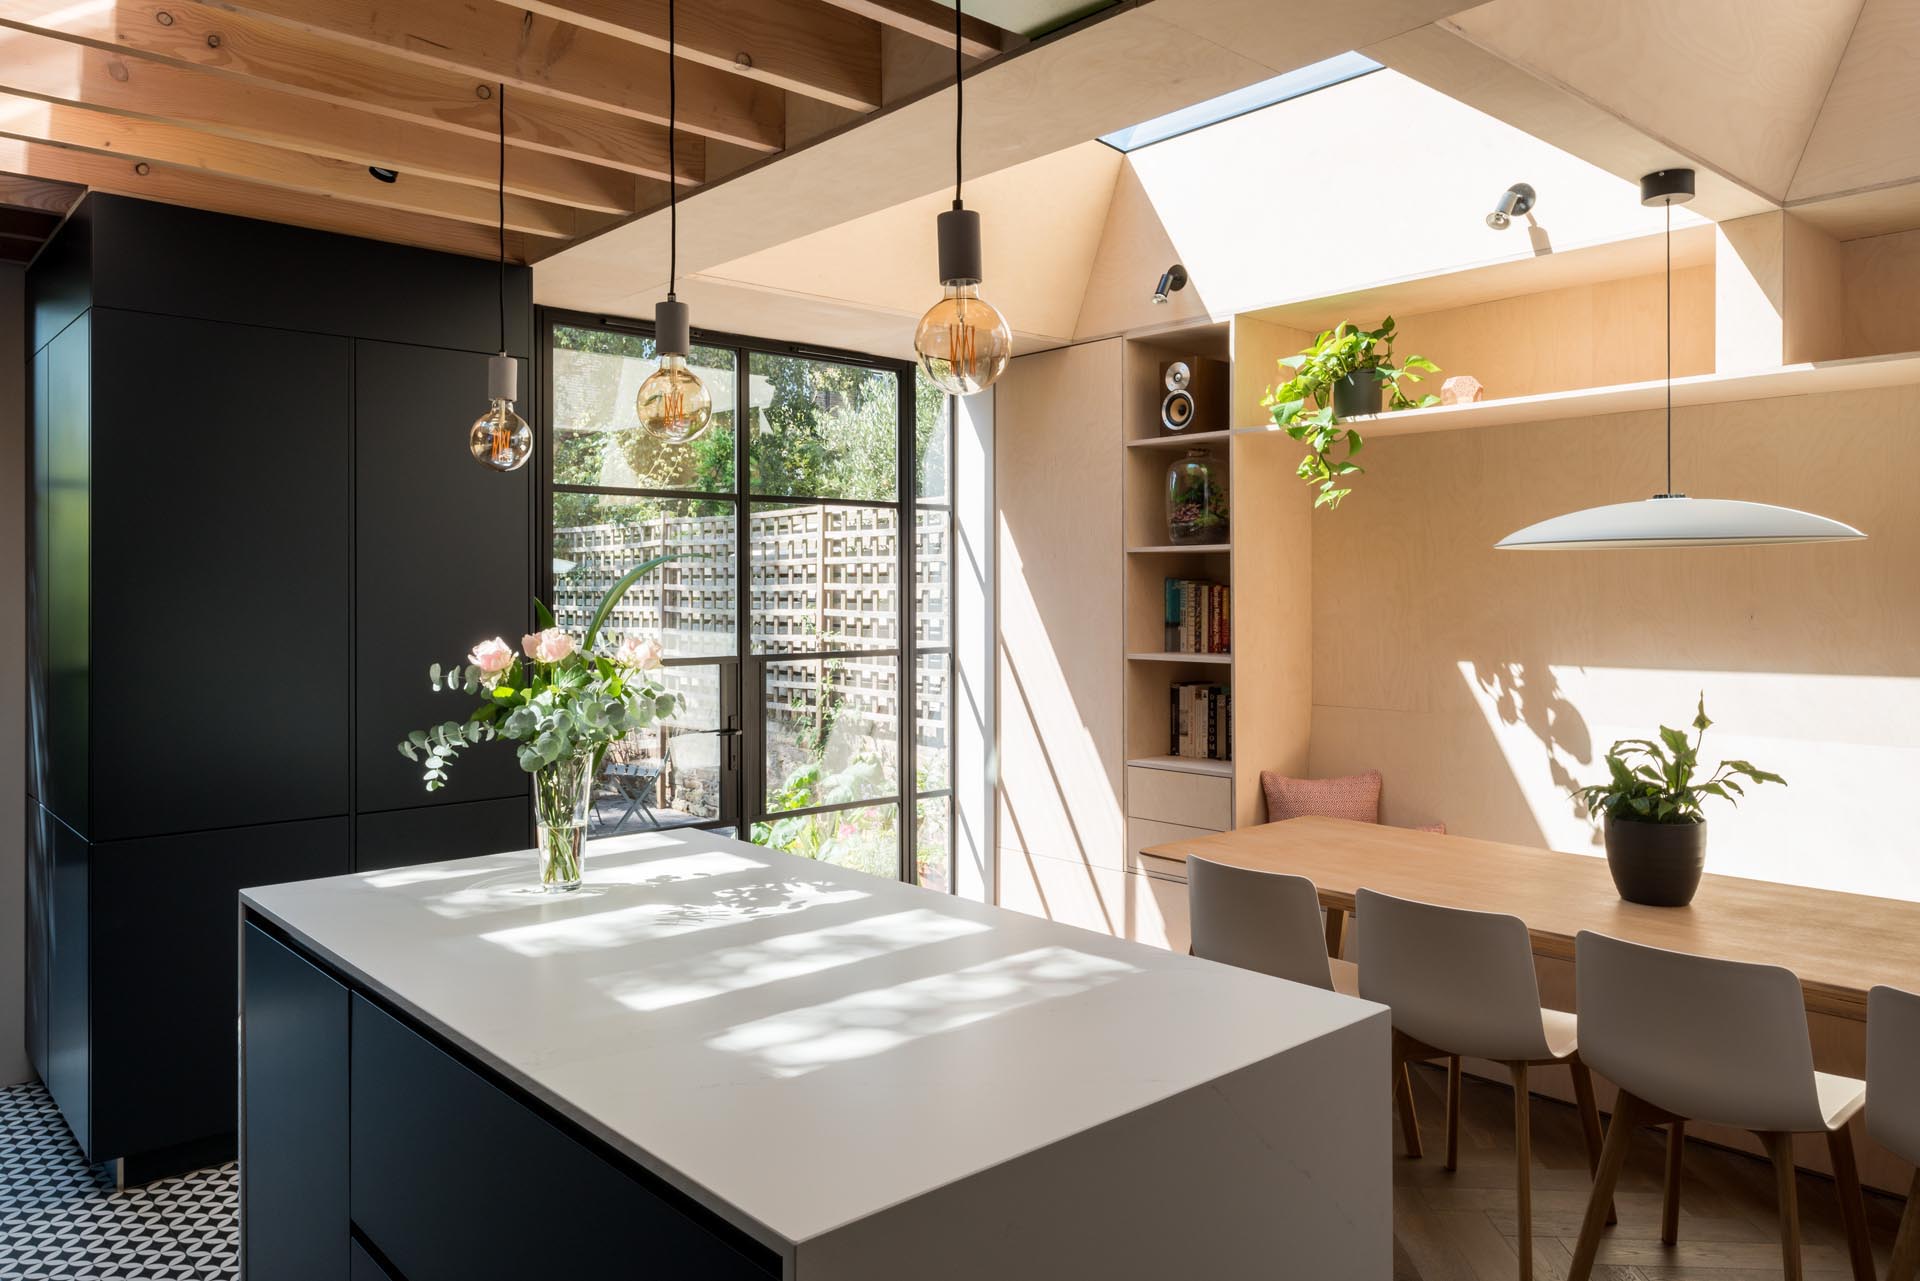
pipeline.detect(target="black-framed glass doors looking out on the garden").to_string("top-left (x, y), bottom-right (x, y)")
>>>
top-left (541, 313), bottom-right (950, 889)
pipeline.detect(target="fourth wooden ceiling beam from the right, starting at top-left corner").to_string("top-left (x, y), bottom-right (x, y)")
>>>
top-left (0, 0), bottom-right (705, 184)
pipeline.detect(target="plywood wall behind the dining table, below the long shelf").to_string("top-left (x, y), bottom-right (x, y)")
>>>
top-left (1311, 388), bottom-right (1920, 899)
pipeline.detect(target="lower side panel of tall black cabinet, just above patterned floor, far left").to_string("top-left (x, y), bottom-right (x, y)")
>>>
top-left (42, 814), bottom-right (94, 1154)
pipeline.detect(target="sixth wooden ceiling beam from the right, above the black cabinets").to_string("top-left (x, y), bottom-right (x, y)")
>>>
top-left (0, 94), bottom-right (602, 238)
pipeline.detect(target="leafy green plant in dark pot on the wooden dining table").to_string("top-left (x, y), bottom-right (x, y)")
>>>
top-left (1574, 695), bottom-right (1788, 906)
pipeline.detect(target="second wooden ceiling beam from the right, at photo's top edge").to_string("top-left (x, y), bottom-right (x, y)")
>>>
top-left (520, 0), bottom-right (881, 111)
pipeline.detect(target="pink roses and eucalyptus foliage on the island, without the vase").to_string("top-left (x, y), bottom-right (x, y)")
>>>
top-left (399, 557), bottom-right (680, 791)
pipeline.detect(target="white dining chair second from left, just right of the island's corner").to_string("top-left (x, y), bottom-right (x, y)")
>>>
top-left (1354, 889), bottom-right (1599, 1281)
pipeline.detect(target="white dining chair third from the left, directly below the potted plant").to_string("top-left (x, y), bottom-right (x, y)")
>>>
top-left (1569, 931), bottom-right (1874, 1281)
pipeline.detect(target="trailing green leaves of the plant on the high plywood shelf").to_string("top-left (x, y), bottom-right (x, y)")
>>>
top-left (1260, 317), bottom-right (1440, 507)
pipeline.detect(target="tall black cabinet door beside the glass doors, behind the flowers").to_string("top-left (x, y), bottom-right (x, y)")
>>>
top-left (353, 342), bottom-right (536, 812)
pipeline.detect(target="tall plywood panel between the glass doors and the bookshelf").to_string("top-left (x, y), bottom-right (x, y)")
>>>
top-left (995, 338), bottom-right (1123, 898)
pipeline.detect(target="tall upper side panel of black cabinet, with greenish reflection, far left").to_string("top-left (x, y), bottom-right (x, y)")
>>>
top-left (42, 313), bottom-right (92, 835)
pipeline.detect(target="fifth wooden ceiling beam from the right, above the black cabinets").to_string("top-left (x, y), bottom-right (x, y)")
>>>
top-left (0, 25), bottom-right (641, 213)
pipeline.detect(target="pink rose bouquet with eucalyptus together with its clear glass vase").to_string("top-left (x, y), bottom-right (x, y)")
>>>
top-left (399, 557), bottom-right (680, 889)
